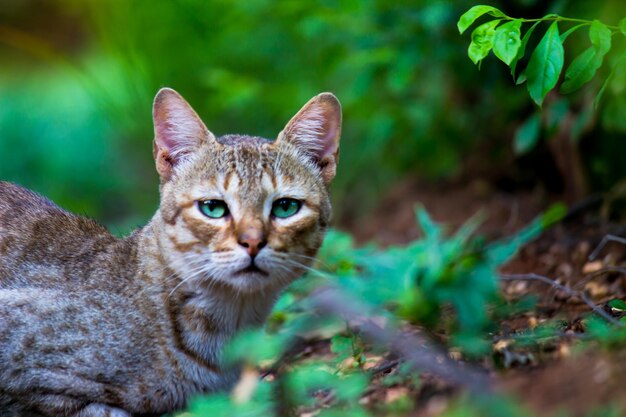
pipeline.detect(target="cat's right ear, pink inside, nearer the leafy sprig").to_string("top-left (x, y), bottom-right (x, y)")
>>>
top-left (276, 93), bottom-right (341, 184)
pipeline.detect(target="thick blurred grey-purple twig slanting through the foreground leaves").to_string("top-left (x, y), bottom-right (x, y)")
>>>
top-left (308, 287), bottom-right (491, 395)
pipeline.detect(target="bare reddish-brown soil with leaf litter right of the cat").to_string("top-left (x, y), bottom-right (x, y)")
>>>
top-left (324, 180), bottom-right (626, 416)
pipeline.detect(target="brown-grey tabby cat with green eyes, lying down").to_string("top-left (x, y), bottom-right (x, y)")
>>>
top-left (0, 88), bottom-right (341, 417)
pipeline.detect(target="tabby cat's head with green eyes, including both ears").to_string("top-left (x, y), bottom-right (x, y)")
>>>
top-left (153, 89), bottom-right (341, 293)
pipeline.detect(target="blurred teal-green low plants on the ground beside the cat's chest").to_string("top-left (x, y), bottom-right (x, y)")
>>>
top-left (176, 205), bottom-right (565, 417)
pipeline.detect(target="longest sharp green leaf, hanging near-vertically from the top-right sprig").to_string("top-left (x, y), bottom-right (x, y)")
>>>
top-left (526, 22), bottom-right (564, 106)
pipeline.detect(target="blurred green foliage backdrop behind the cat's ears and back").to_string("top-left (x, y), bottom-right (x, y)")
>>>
top-left (0, 0), bottom-right (626, 229)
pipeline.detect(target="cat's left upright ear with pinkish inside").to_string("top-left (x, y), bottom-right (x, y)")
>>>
top-left (152, 88), bottom-right (215, 181)
